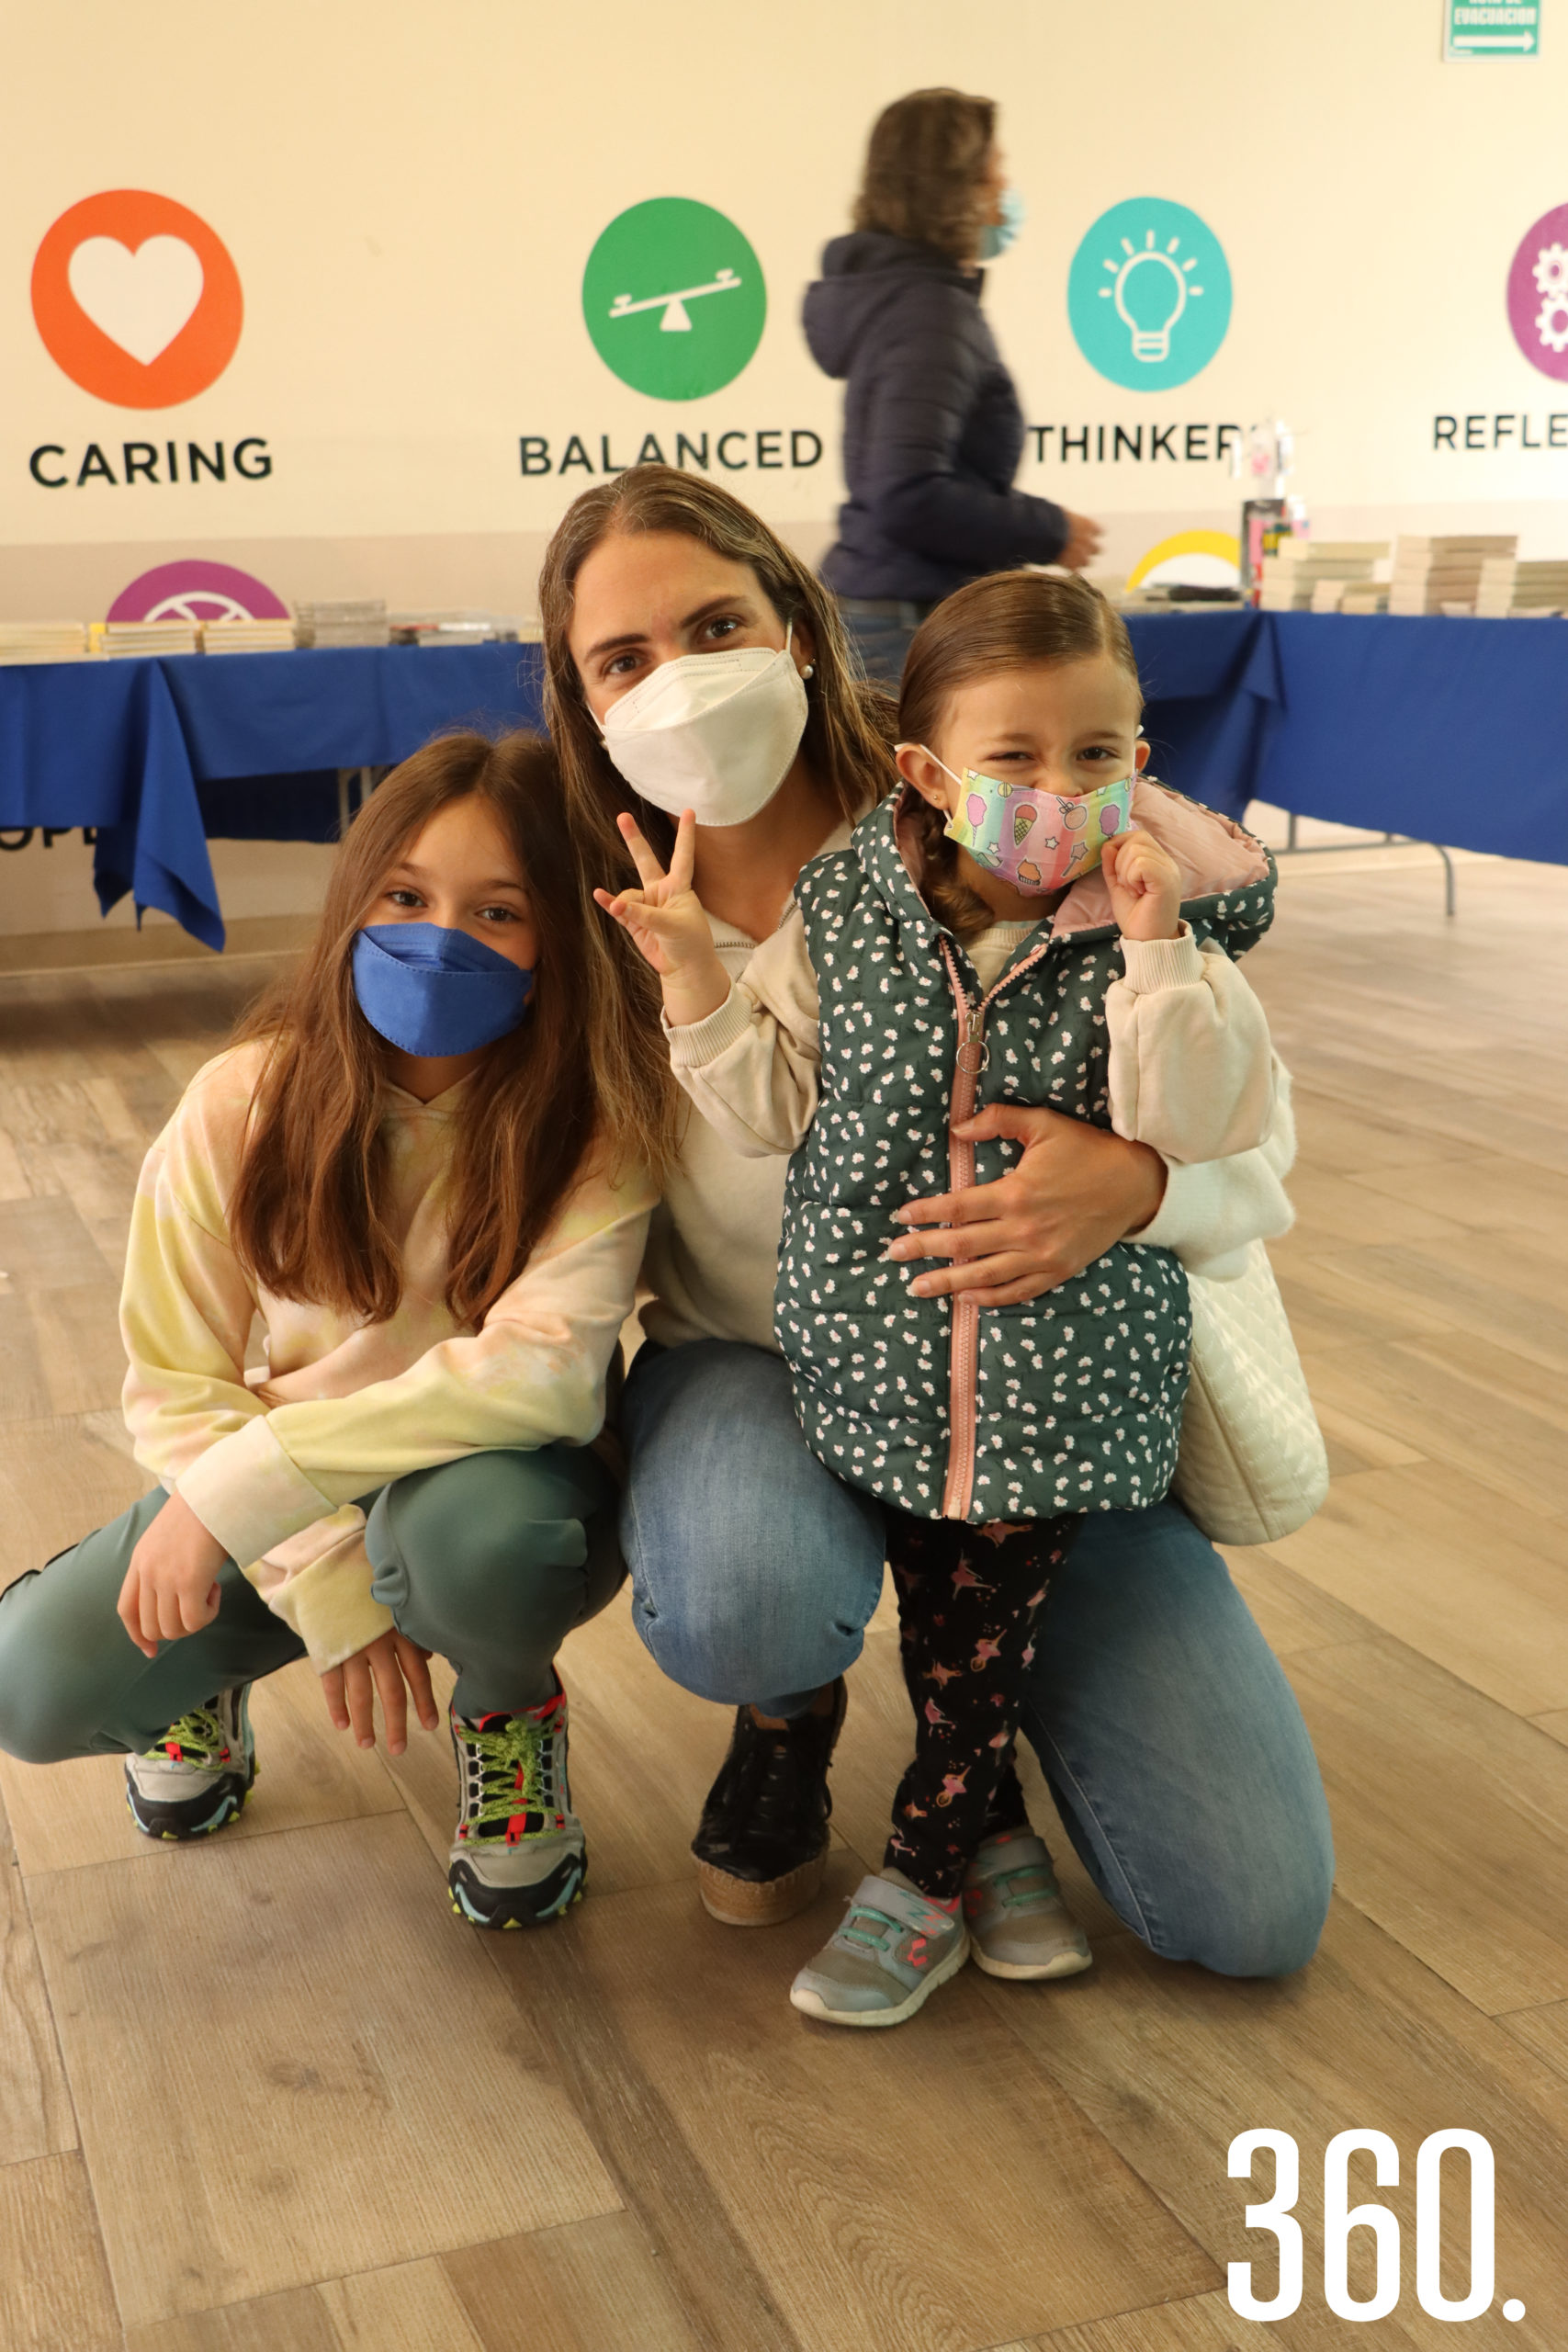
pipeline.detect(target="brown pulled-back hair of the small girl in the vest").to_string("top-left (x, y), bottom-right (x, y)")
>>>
top-left (898, 571), bottom-right (1143, 938)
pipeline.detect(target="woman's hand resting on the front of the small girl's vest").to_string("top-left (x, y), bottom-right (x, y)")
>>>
top-left (888, 1103), bottom-right (1166, 1307)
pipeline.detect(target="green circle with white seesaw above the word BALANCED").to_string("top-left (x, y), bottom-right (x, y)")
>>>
top-left (583, 195), bottom-right (769, 400)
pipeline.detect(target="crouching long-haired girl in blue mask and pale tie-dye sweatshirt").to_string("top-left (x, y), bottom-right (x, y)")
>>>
top-left (0, 734), bottom-right (680, 1928)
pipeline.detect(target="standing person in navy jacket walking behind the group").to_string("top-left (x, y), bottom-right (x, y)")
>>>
top-left (804, 89), bottom-right (1100, 684)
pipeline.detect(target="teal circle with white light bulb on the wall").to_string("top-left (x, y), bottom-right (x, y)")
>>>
top-left (1067, 195), bottom-right (1229, 393)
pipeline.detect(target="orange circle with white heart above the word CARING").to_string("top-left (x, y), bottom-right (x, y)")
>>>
top-left (33, 188), bottom-right (244, 409)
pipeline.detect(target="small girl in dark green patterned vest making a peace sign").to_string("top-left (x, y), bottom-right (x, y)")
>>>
top-left (597, 571), bottom-right (1274, 2025)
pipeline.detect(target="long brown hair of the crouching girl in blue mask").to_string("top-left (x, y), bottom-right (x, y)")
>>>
top-left (228, 734), bottom-right (677, 1324)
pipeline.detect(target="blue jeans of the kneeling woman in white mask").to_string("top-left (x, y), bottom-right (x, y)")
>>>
top-left (621, 1340), bottom-right (1333, 1975)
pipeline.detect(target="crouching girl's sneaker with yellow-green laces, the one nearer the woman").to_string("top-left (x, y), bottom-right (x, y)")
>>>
top-left (446, 1679), bottom-right (588, 1927)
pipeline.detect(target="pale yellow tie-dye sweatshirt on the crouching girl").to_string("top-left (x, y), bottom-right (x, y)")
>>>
top-left (120, 1045), bottom-right (653, 1672)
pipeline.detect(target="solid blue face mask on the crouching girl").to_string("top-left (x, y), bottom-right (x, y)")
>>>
top-left (355, 922), bottom-right (534, 1056)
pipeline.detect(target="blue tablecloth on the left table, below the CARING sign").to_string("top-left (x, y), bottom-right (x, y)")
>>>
top-left (0, 644), bottom-right (538, 948)
